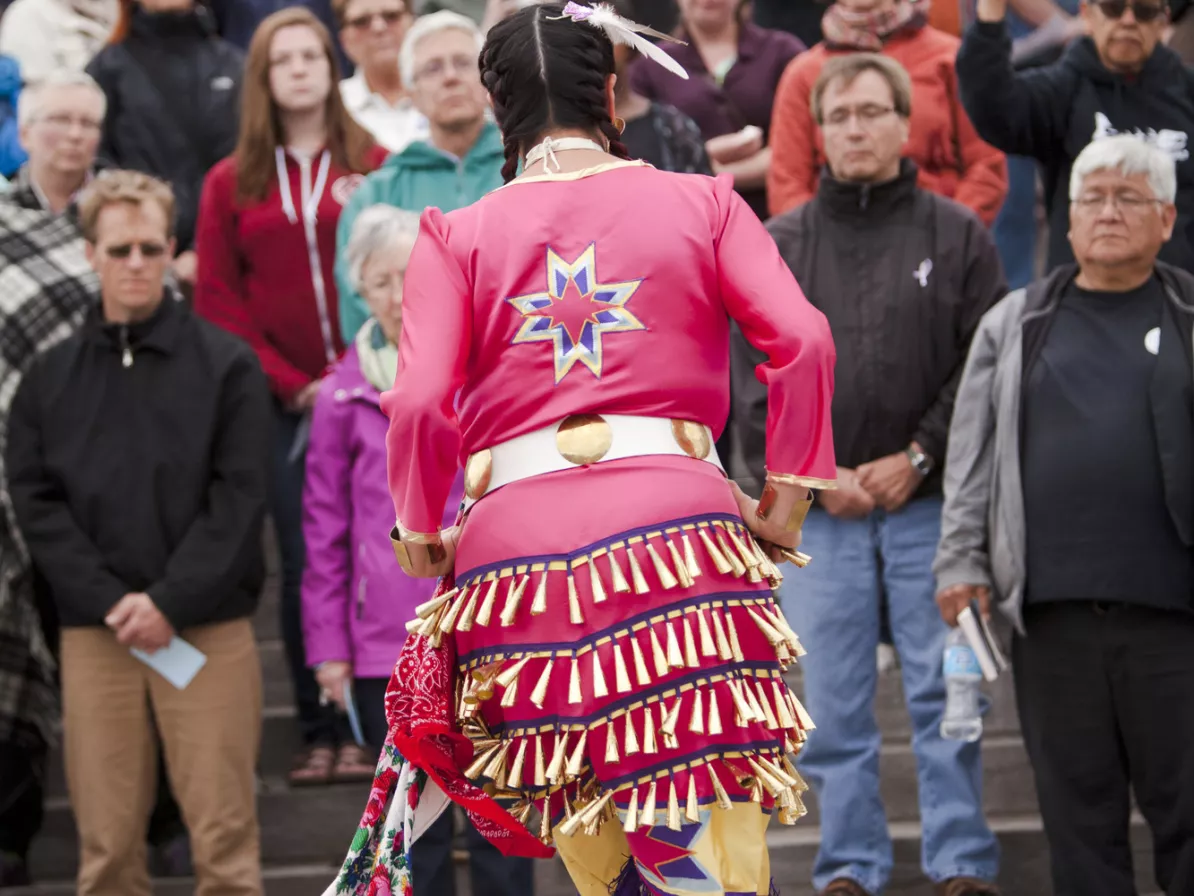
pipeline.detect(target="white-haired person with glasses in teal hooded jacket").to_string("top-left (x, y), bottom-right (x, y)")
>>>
top-left (336, 11), bottom-right (505, 343)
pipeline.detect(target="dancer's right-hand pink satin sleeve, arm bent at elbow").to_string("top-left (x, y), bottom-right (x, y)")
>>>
top-left (715, 174), bottom-right (837, 489)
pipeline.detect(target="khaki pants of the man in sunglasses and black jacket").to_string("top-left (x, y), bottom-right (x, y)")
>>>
top-left (62, 619), bottom-right (261, 896)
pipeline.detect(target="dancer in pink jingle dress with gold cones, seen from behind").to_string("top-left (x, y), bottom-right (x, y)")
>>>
top-left (353, 4), bottom-right (836, 896)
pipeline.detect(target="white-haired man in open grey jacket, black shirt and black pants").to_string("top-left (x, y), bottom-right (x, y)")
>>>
top-left (935, 136), bottom-right (1194, 896)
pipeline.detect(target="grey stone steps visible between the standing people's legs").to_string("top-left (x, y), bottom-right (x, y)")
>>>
top-left (5, 551), bottom-right (1159, 896)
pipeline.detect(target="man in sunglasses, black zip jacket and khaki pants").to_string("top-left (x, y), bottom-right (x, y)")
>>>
top-left (6, 171), bottom-right (270, 896)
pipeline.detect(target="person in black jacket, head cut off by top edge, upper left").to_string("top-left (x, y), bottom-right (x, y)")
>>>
top-left (87, 0), bottom-right (244, 293)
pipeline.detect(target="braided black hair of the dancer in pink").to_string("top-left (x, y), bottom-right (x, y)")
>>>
top-left (481, 4), bottom-right (630, 183)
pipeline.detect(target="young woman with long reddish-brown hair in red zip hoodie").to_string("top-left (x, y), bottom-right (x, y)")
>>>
top-left (195, 7), bottom-right (383, 786)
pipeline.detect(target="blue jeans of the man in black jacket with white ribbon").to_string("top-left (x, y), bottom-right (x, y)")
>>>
top-left (783, 498), bottom-right (999, 894)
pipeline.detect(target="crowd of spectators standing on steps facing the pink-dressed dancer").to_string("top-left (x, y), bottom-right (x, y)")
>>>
top-left (0, 0), bottom-right (1194, 896)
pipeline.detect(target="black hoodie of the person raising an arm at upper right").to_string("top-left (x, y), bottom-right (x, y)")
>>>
top-left (958, 22), bottom-right (1194, 272)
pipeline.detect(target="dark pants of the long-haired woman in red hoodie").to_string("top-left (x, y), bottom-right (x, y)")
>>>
top-left (270, 401), bottom-right (344, 747)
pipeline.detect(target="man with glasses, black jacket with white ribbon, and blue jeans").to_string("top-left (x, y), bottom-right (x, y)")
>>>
top-left (736, 54), bottom-right (1004, 896)
